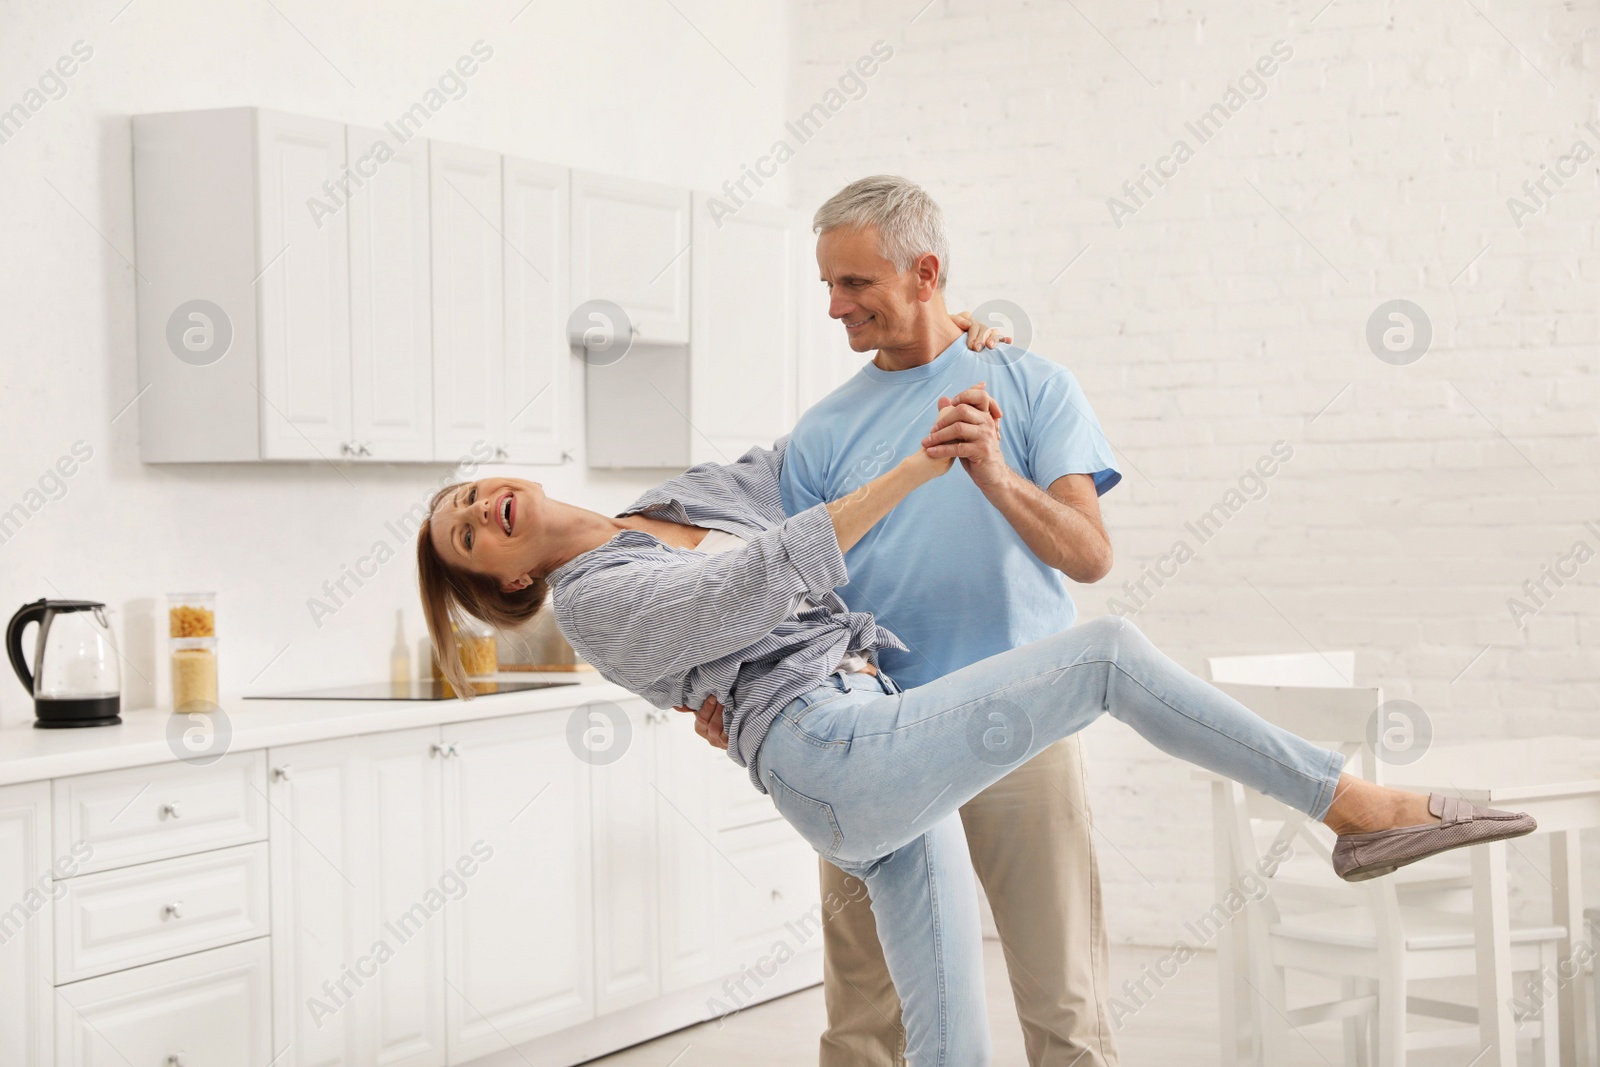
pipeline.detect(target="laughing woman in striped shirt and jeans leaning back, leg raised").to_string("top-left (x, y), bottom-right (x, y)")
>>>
top-left (418, 403), bottom-right (1534, 1067)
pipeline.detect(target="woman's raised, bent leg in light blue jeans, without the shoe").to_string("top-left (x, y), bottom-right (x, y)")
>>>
top-left (758, 616), bottom-right (1344, 862)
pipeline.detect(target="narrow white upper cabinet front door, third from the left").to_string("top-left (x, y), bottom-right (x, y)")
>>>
top-left (429, 141), bottom-right (506, 462)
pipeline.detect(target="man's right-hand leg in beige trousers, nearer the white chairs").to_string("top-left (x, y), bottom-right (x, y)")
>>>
top-left (962, 736), bottom-right (1118, 1067)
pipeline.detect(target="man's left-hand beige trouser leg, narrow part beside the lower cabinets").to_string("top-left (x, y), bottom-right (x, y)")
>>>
top-left (818, 859), bottom-right (906, 1067)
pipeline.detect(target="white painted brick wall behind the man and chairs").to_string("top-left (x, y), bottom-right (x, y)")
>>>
top-left (790, 0), bottom-right (1600, 944)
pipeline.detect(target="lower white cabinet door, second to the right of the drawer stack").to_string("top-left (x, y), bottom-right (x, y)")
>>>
top-left (443, 712), bottom-right (594, 1064)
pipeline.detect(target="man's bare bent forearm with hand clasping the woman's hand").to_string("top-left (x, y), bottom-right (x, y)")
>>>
top-left (922, 386), bottom-right (1112, 582)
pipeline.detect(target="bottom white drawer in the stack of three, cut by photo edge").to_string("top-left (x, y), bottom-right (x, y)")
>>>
top-left (56, 937), bottom-right (272, 1067)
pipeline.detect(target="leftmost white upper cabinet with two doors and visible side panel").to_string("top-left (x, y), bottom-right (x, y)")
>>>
top-left (133, 107), bottom-right (434, 462)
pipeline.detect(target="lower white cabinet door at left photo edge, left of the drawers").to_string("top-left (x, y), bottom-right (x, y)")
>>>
top-left (0, 782), bottom-right (51, 1064)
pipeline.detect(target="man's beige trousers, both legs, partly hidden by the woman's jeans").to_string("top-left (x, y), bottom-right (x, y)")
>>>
top-left (819, 737), bottom-right (1117, 1067)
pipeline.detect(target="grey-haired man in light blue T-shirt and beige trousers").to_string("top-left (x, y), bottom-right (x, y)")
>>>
top-left (696, 176), bottom-right (1122, 1067)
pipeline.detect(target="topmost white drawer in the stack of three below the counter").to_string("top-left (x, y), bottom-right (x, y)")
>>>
top-left (53, 752), bottom-right (267, 873)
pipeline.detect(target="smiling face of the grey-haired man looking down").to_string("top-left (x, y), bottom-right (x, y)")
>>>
top-left (816, 226), bottom-right (920, 352)
